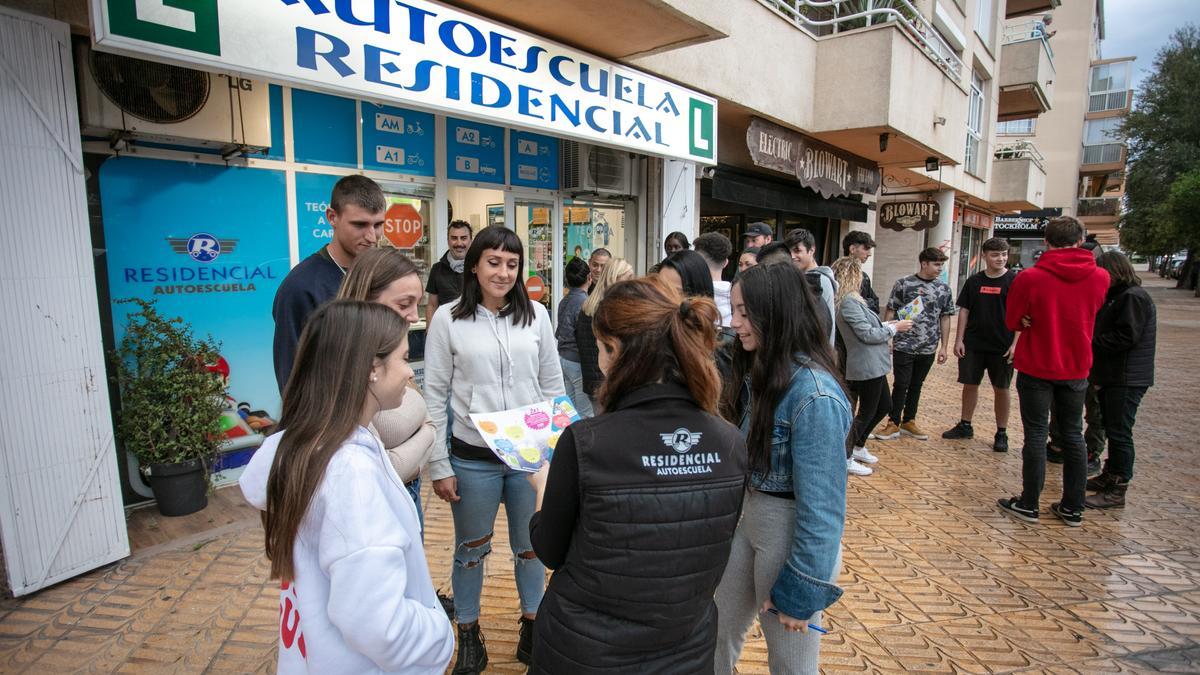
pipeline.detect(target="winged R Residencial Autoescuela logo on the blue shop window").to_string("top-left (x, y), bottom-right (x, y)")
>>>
top-left (121, 232), bottom-right (278, 295)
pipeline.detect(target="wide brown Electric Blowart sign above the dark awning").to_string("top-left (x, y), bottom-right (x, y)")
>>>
top-left (746, 118), bottom-right (880, 199)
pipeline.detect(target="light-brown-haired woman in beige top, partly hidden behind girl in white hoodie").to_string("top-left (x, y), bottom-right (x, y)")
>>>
top-left (337, 247), bottom-right (433, 531)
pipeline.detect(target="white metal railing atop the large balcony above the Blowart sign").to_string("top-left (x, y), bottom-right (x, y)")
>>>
top-left (758, 0), bottom-right (962, 82)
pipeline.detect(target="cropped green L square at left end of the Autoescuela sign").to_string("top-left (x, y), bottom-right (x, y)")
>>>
top-left (107, 0), bottom-right (221, 56)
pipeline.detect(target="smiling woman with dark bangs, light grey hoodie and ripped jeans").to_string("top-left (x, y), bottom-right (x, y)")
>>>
top-left (425, 226), bottom-right (565, 674)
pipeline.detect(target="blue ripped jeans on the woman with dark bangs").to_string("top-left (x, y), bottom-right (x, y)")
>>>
top-left (450, 455), bottom-right (546, 623)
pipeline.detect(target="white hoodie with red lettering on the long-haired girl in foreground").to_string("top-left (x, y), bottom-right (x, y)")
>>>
top-left (238, 426), bottom-right (454, 675)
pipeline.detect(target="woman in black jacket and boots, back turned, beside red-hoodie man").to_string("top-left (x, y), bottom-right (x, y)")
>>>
top-left (1084, 251), bottom-right (1158, 508)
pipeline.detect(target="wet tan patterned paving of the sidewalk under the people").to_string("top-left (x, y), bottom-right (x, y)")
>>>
top-left (0, 277), bottom-right (1200, 674)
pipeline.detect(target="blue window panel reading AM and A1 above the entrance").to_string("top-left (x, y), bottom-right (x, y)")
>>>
top-left (362, 101), bottom-right (434, 175)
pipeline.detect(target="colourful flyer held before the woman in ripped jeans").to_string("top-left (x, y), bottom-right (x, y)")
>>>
top-left (470, 396), bottom-right (580, 473)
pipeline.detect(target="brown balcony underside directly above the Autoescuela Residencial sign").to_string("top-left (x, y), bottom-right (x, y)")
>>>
top-left (452, 0), bottom-right (727, 60)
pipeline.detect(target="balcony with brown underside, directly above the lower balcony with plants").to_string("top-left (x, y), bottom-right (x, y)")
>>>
top-left (996, 20), bottom-right (1055, 121)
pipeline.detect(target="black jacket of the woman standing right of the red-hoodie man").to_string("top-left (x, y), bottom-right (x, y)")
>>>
top-left (1090, 286), bottom-right (1158, 387)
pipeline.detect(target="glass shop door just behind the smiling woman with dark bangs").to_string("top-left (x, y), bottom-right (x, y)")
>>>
top-left (504, 192), bottom-right (563, 321)
